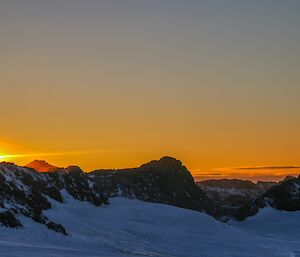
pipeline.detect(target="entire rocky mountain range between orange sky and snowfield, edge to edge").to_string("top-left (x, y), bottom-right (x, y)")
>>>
top-left (0, 157), bottom-right (300, 234)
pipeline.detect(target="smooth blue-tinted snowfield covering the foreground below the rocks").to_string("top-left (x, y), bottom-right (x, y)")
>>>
top-left (0, 193), bottom-right (300, 257)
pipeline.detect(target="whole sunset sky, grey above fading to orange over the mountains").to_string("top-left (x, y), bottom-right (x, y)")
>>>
top-left (0, 0), bottom-right (300, 180)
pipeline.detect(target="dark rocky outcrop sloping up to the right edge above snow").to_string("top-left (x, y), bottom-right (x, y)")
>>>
top-left (235, 176), bottom-right (300, 220)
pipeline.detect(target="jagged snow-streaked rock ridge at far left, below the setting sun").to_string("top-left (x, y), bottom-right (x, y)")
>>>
top-left (0, 162), bottom-right (107, 234)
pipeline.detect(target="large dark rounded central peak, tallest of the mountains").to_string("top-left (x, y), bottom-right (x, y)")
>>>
top-left (88, 157), bottom-right (213, 213)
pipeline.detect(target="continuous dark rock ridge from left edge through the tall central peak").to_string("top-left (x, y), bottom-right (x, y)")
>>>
top-left (0, 157), bottom-right (213, 234)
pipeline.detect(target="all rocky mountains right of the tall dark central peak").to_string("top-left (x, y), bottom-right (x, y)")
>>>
top-left (196, 176), bottom-right (300, 221)
